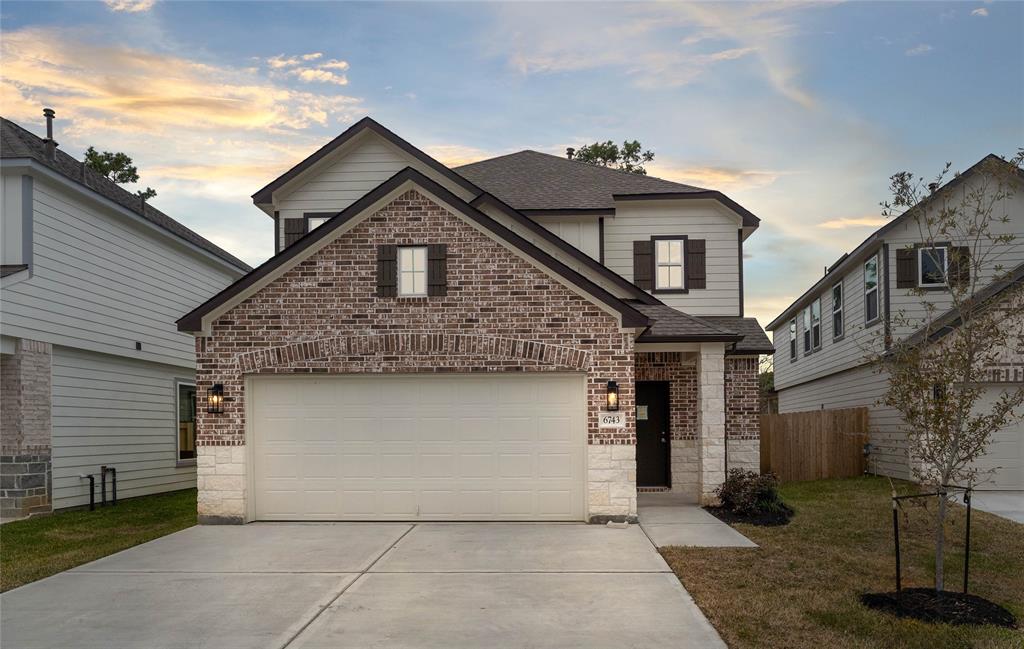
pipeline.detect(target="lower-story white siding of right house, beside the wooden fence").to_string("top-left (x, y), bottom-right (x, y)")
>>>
top-left (776, 360), bottom-right (910, 479)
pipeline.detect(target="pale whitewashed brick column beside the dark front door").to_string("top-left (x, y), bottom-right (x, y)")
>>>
top-left (697, 343), bottom-right (725, 505)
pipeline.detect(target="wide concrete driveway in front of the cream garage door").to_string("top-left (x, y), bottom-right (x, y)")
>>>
top-left (0, 523), bottom-right (725, 649)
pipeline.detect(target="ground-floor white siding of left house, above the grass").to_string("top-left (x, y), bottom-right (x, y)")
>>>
top-left (52, 347), bottom-right (196, 509)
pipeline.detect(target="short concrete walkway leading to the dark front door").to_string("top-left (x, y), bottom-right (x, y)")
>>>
top-left (637, 493), bottom-right (758, 548)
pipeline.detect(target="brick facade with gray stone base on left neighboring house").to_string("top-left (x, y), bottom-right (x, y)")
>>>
top-left (0, 339), bottom-right (52, 518)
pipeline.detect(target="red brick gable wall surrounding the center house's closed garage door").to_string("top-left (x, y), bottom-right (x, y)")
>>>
top-left (196, 190), bottom-right (635, 446)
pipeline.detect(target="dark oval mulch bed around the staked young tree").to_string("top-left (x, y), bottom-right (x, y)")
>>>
top-left (860, 589), bottom-right (1017, 629)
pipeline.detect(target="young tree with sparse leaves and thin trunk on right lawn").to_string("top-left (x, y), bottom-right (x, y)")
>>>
top-left (871, 149), bottom-right (1024, 591)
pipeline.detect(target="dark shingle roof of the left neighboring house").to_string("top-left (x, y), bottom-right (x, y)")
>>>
top-left (0, 118), bottom-right (252, 271)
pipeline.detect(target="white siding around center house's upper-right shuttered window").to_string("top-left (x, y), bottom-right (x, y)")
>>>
top-left (604, 201), bottom-right (740, 315)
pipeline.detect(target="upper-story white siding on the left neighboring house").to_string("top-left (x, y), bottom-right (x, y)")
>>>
top-left (0, 177), bottom-right (241, 367)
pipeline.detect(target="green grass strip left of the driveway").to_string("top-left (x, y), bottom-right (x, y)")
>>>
top-left (0, 489), bottom-right (196, 592)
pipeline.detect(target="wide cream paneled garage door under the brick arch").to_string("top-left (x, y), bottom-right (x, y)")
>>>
top-left (250, 374), bottom-right (586, 520)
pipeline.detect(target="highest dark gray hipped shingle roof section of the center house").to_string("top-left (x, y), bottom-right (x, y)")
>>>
top-left (455, 150), bottom-right (708, 210)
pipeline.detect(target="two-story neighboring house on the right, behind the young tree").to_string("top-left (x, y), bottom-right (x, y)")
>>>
top-left (768, 156), bottom-right (1024, 489)
